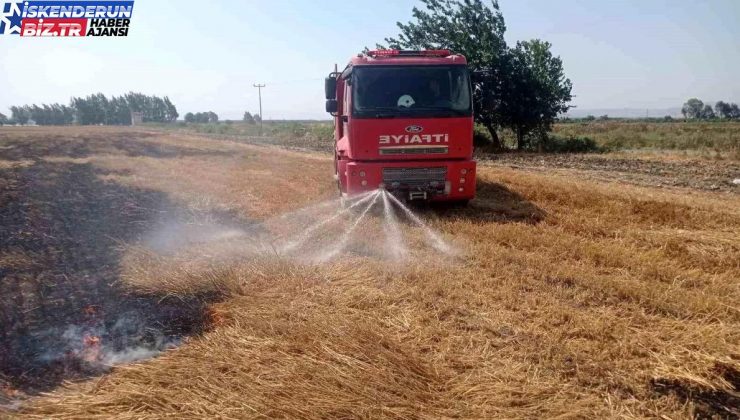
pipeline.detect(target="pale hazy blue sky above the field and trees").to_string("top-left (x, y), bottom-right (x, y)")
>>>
top-left (0, 0), bottom-right (740, 119)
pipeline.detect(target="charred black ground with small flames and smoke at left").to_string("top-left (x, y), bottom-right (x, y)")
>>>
top-left (0, 133), bottom-right (231, 397)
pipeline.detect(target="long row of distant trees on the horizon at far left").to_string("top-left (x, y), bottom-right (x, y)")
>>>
top-left (0, 92), bottom-right (179, 125)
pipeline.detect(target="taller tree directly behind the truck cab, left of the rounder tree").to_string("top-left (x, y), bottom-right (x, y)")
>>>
top-left (378, 0), bottom-right (509, 148)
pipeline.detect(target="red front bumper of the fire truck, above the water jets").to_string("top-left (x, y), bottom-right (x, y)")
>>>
top-left (341, 160), bottom-right (475, 201)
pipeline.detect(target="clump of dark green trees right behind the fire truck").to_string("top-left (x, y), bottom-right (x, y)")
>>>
top-left (379, 0), bottom-right (572, 148)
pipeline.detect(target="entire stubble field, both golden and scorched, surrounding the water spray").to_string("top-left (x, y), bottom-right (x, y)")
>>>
top-left (0, 128), bottom-right (740, 418)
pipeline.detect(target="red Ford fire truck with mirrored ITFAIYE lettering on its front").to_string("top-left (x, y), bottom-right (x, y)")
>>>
top-left (324, 50), bottom-right (475, 201)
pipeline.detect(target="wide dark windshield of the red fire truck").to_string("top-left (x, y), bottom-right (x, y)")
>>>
top-left (352, 66), bottom-right (472, 118)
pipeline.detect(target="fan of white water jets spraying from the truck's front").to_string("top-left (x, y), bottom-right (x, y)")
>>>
top-left (143, 189), bottom-right (452, 263)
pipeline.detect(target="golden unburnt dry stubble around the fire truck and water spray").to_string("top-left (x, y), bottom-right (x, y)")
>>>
top-left (2, 126), bottom-right (740, 418)
